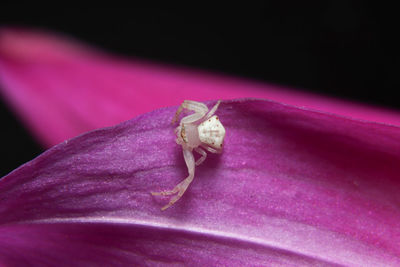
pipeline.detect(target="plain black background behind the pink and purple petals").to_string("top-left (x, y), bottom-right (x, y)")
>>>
top-left (0, 4), bottom-right (400, 176)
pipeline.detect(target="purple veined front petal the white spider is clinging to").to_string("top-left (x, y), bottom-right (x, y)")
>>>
top-left (0, 100), bottom-right (400, 266)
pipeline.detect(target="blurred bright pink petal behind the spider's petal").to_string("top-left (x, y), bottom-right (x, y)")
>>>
top-left (0, 29), bottom-right (400, 146)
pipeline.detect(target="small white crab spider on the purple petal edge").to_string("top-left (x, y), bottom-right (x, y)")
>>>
top-left (151, 100), bottom-right (225, 210)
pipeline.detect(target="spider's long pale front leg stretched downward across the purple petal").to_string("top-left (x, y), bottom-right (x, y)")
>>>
top-left (151, 149), bottom-right (195, 210)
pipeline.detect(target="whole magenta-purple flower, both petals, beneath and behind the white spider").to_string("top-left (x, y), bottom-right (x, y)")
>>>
top-left (0, 30), bottom-right (400, 266)
